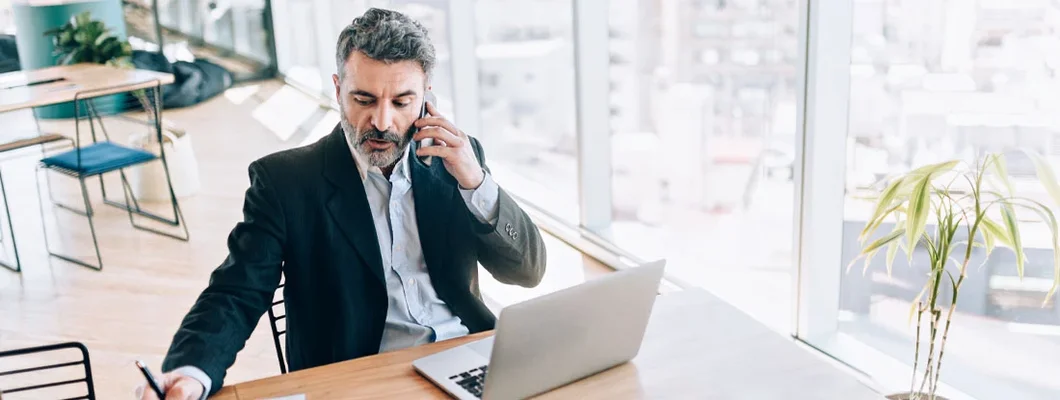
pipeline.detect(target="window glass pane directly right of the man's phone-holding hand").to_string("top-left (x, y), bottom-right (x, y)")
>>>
top-left (475, 0), bottom-right (578, 223)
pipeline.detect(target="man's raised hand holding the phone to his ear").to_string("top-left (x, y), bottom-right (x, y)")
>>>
top-left (412, 102), bottom-right (485, 190)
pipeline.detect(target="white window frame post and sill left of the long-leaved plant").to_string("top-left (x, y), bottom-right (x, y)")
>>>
top-left (792, 0), bottom-right (1000, 400)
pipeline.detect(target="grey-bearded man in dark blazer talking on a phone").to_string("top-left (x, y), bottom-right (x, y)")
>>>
top-left (140, 8), bottom-right (545, 399)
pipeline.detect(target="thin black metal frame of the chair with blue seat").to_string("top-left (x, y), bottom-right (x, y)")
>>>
top-left (37, 80), bottom-right (191, 271)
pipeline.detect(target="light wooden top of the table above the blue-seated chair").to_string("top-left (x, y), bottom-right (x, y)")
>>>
top-left (0, 64), bottom-right (173, 112)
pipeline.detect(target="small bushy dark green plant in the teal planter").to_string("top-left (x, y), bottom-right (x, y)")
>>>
top-left (45, 12), bottom-right (133, 68)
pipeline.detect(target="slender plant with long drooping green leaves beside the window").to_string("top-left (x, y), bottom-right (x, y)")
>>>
top-left (848, 152), bottom-right (1060, 400)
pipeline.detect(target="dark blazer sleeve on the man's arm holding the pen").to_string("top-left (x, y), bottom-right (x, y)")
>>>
top-left (162, 161), bottom-right (285, 394)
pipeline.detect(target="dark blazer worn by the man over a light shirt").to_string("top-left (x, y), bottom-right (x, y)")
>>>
top-left (162, 126), bottom-right (545, 392)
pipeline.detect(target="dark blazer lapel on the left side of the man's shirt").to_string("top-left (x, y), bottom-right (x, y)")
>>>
top-left (324, 125), bottom-right (386, 284)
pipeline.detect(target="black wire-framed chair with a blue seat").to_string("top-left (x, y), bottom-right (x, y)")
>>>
top-left (37, 81), bottom-right (190, 271)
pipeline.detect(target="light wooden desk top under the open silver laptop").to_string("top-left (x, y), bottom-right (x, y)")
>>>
top-left (214, 290), bottom-right (883, 400)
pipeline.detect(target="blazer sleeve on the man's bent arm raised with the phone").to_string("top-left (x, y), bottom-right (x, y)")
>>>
top-left (471, 138), bottom-right (546, 288)
